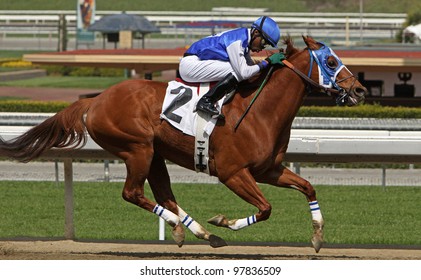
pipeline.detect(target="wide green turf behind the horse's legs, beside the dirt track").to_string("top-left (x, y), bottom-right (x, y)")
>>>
top-left (0, 181), bottom-right (421, 245)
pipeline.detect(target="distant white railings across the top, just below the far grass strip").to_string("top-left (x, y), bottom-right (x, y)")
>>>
top-left (0, 9), bottom-right (407, 42)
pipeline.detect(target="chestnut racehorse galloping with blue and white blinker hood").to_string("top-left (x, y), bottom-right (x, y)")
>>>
top-left (0, 36), bottom-right (367, 252)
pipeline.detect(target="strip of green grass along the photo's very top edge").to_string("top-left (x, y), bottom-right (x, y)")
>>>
top-left (1, 0), bottom-right (419, 13)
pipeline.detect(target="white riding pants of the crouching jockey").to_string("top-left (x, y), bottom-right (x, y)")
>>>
top-left (179, 55), bottom-right (239, 83)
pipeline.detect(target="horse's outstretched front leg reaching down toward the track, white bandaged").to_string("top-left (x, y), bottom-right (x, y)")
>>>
top-left (256, 165), bottom-right (324, 252)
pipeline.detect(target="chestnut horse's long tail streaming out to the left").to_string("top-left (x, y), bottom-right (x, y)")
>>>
top-left (0, 98), bottom-right (92, 162)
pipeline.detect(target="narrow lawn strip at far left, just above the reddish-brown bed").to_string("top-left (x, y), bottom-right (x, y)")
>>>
top-left (0, 76), bottom-right (125, 89)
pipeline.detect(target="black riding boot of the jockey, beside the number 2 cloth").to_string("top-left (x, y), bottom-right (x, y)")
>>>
top-left (196, 73), bottom-right (238, 116)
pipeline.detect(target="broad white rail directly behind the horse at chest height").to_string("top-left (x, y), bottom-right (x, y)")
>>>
top-left (0, 126), bottom-right (421, 163)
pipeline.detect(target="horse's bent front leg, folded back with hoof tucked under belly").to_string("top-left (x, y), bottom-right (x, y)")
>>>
top-left (208, 169), bottom-right (272, 230)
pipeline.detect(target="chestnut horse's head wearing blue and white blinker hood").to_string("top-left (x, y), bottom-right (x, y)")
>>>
top-left (287, 36), bottom-right (367, 106)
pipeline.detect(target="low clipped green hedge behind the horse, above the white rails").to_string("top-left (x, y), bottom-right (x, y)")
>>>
top-left (0, 100), bottom-right (421, 119)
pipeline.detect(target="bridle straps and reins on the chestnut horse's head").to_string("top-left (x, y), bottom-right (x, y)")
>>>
top-left (282, 49), bottom-right (356, 106)
